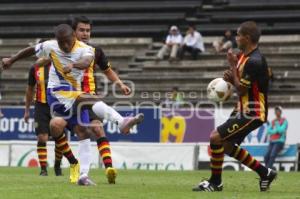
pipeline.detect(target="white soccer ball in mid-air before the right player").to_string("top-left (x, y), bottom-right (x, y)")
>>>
top-left (207, 78), bottom-right (233, 102)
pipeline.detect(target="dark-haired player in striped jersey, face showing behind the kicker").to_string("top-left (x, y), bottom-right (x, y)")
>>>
top-left (72, 16), bottom-right (130, 184)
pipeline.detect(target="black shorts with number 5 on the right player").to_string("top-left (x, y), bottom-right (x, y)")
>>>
top-left (217, 114), bottom-right (263, 145)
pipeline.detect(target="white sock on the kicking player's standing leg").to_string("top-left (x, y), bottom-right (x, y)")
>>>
top-left (78, 139), bottom-right (91, 176)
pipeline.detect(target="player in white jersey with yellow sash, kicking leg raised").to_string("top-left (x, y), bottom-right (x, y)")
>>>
top-left (2, 24), bottom-right (144, 185)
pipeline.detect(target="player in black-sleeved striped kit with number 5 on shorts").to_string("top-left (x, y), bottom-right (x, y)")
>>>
top-left (193, 21), bottom-right (277, 192)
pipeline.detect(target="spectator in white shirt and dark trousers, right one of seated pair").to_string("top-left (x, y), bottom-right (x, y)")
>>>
top-left (179, 25), bottom-right (205, 60)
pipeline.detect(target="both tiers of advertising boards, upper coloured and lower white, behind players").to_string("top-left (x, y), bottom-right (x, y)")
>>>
top-left (0, 107), bottom-right (300, 171)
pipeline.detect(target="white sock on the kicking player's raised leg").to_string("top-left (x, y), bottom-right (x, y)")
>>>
top-left (92, 101), bottom-right (124, 125)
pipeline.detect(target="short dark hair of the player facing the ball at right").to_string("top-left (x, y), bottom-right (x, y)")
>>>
top-left (239, 21), bottom-right (261, 44)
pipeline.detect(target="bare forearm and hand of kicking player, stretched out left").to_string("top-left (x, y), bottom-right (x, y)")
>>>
top-left (1, 47), bottom-right (35, 69)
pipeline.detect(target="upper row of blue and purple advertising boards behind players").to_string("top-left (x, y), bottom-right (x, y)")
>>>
top-left (0, 107), bottom-right (300, 144)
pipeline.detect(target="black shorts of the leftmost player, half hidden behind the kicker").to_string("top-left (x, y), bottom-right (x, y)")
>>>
top-left (34, 102), bottom-right (51, 135)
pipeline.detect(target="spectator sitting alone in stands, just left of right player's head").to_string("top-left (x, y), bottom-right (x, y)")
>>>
top-left (213, 29), bottom-right (237, 53)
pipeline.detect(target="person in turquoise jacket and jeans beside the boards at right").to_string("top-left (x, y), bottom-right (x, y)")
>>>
top-left (264, 106), bottom-right (288, 168)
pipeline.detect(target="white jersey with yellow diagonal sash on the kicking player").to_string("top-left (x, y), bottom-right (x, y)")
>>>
top-left (35, 40), bottom-right (95, 111)
